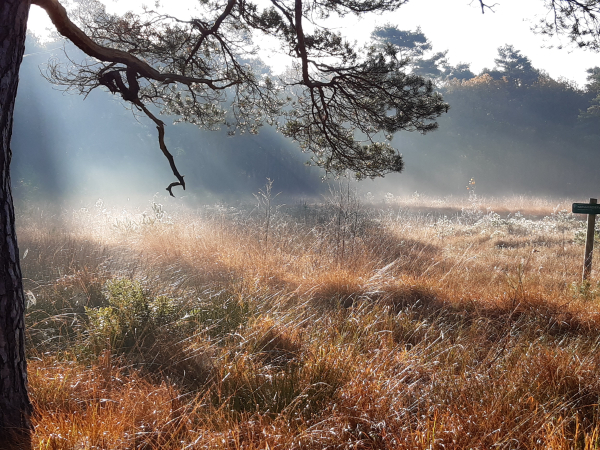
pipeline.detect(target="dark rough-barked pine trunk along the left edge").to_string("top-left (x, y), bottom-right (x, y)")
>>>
top-left (0, 0), bottom-right (31, 450)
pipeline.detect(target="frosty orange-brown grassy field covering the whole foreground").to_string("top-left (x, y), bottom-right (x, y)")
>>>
top-left (18, 189), bottom-right (600, 450)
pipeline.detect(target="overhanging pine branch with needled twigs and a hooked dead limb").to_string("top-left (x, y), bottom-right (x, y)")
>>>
top-left (34, 0), bottom-right (448, 195)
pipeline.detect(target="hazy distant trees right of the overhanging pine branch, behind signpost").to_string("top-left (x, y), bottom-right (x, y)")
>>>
top-left (373, 25), bottom-right (600, 196)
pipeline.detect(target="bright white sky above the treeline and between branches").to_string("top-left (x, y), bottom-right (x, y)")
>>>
top-left (29, 0), bottom-right (600, 86)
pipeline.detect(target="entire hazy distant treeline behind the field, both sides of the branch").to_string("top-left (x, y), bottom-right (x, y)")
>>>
top-left (12, 29), bottom-right (600, 200)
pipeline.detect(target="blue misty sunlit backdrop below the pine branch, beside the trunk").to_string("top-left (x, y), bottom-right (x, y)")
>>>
top-left (12, 36), bottom-right (325, 207)
